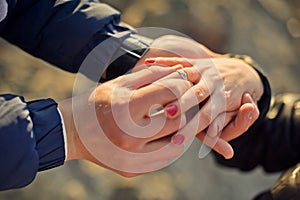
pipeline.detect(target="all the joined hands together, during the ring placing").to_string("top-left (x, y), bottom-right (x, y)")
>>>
top-left (59, 36), bottom-right (263, 176)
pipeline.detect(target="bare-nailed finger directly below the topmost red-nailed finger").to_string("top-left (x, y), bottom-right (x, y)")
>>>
top-left (118, 66), bottom-right (177, 89)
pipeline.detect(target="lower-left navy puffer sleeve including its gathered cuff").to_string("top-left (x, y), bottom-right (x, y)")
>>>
top-left (0, 94), bottom-right (65, 190)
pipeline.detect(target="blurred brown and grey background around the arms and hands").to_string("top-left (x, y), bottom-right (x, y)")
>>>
top-left (0, 0), bottom-right (300, 200)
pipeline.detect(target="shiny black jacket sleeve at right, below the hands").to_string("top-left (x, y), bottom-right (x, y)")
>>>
top-left (216, 93), bottom-right (300, 172)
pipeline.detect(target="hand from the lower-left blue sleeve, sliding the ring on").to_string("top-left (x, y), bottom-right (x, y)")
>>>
top-left (59, 65), bottom-right (192, 176)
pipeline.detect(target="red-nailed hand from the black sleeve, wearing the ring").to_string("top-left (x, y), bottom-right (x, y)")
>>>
top-left (145, 57), bottom-right (263, 158)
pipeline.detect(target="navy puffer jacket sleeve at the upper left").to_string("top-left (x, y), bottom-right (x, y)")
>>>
top-left (0, 0), bottom-right (133, 72)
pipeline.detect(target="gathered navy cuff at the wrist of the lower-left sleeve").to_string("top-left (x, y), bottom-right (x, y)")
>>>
top-left (27, 99), bottom-right (65, 171)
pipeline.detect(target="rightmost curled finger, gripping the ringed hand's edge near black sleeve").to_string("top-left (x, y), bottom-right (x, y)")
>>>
top-left (221, 94), bottom-right (259, 141)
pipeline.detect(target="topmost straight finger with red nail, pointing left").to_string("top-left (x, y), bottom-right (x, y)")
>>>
top-left (145, 57), bottom-right (192, 67)
